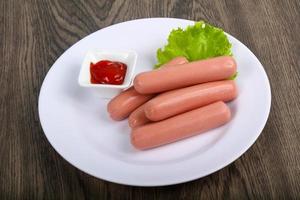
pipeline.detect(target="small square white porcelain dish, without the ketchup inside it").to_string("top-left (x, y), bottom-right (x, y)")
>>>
top-left (78, 50), bottom-right (137, 98)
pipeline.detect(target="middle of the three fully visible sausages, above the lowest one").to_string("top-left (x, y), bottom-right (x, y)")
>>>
top-left (145, 80), bottom-right (237, 121)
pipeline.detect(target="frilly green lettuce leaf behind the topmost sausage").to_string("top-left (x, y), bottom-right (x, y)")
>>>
top-left (155, 21), bottom-right (232, 68)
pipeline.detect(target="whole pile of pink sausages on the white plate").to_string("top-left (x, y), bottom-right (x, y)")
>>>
top-left (107, 56), bottom-right (237, 150)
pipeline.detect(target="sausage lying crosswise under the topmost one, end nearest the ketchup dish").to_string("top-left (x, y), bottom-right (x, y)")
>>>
top-left (107, 57), bottom-right (188, 121)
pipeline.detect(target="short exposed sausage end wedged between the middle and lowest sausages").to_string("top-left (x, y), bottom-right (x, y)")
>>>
top-left (128, 104), bottom-right (150, 128)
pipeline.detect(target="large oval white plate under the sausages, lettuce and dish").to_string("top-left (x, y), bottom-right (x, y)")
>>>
top-left (39, 18), bottom-right (271, 186)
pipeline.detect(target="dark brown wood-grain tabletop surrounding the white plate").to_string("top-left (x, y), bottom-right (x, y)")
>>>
top-left (0, 0), bottom-right (300, 200)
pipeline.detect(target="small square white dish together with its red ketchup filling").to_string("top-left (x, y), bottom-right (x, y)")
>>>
top-left (78, 50), bottom-right (137, 99)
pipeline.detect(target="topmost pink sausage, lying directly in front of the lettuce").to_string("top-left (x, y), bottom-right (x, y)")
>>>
top-left (133, 56), bottom-right (236, 94)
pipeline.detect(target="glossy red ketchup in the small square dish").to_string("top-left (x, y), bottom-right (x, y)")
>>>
top-left (90, 60), bottom-right (127, 85)
